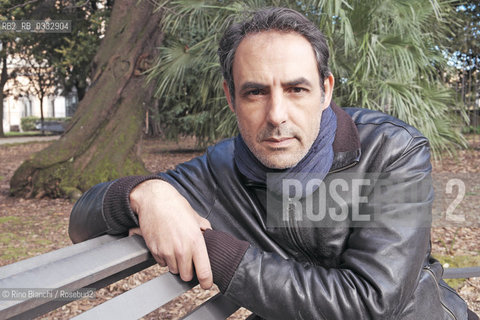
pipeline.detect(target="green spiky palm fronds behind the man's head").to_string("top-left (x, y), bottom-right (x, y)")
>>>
top-left (148, 0), bottom-right (464, 155)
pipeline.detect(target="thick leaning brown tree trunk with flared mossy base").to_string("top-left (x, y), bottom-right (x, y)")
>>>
top-left (10, 0), bottom-right (162, 197)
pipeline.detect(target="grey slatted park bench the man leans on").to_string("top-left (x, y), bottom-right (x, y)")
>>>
top-left (0, 235), bottom-right (480, 320)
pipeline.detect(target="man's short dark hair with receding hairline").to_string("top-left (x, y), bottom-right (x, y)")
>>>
top-left (218, 7), bottom-right (330, 100)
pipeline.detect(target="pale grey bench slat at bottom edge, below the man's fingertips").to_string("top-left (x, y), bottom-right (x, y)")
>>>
top-left (74, 273), bottom-right (197, 320)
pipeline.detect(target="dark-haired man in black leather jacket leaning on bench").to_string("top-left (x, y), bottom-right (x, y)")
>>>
top-left (69, 8), bottom-right (474, 319)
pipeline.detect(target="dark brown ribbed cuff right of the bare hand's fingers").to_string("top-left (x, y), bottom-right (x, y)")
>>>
top-left (203, 229), bottom-right (250, 293)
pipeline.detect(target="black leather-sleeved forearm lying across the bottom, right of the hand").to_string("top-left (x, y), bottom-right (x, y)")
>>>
top-left (212, 225), bottom-right (428, 319)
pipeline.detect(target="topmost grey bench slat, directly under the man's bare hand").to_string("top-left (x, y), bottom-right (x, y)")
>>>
top-left (0, 236), bottom-right (153, 318)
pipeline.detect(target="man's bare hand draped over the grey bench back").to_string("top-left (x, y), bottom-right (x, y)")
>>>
top-left (130, 180), bottom-right (213, 289)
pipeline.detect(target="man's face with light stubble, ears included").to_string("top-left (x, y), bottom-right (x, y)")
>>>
top-left (224, 31), bottom-right (333, 169)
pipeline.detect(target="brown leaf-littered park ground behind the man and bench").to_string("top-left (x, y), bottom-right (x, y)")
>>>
top-left (0, 136), bottom-right (480, 319)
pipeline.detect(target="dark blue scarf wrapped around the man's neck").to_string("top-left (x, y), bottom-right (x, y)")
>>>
top-left (234, 107), bottom-right (337, 194)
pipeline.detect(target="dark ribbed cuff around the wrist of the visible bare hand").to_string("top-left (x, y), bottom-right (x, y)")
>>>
top-left (103, 175), bottom-right (163, 234)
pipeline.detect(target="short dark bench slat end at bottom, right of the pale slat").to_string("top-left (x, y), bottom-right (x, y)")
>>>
top-left (182, 293), bottom-right (238, 320)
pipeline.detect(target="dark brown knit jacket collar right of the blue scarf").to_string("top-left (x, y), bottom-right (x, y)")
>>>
top-left (330, 101), bottom-right (361, 172)
